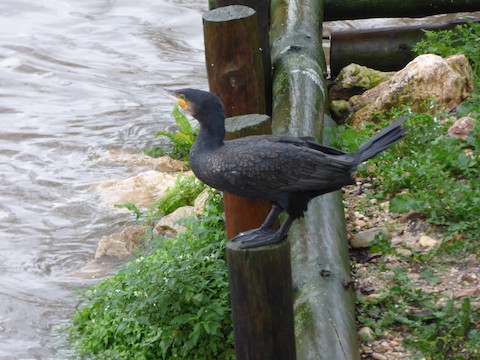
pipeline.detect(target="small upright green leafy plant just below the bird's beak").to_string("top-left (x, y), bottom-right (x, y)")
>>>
top-left (144, 105), bottom-right (197, 162)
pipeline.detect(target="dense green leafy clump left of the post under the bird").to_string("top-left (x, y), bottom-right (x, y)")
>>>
top-left (70, 193), bottom-right (234, 359)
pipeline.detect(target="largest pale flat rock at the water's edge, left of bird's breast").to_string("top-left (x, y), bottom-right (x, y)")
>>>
top-left (96, 170), bottom-right (190, 208)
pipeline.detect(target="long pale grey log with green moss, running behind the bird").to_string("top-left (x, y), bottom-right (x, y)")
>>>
top-left (270, 0), bottom-right (359, 360)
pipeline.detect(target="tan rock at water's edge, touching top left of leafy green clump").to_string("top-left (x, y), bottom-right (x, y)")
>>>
top-left (95, 225), bottom-right (147, 259)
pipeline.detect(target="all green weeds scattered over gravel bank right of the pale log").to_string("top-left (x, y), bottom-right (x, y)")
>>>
top-left (334, 23), bottom-right (480, 359)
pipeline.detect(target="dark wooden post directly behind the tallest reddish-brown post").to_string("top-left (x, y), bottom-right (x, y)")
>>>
top-left (209, 0), bottom-right (272, 115)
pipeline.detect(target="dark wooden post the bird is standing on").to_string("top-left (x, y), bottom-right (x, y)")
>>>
top-left (227, 241), bottom-right (295, 360)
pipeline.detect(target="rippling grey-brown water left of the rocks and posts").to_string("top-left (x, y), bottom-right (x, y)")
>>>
top-left (0, 0), bottom-right (207, 359)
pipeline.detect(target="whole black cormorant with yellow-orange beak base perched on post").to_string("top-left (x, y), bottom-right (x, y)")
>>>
top-left (167, 89), bottom-right (407, 248)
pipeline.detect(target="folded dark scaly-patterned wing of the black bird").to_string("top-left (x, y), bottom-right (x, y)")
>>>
top-left (224, 136), bottom-right (353, 192)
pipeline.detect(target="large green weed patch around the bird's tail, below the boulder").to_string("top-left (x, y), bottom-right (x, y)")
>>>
top-left (337, 109), bottom-right (480, 255)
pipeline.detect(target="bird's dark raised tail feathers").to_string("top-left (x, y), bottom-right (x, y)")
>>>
top-left (354, 116), bottom-right (408, 164)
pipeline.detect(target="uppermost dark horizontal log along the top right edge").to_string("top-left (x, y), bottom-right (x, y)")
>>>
top-left (324, 0), bottom-right (480, 21)
